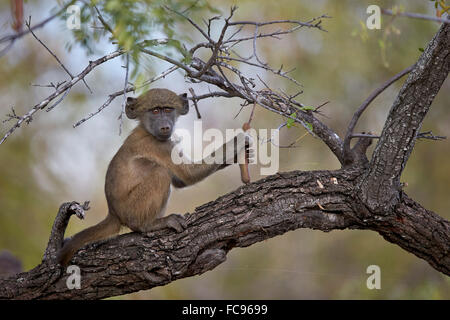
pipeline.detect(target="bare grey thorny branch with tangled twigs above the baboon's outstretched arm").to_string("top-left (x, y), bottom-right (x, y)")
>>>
top-left (137, 7), bottom-right (342, 160)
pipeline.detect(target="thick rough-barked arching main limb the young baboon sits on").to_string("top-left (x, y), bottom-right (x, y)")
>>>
top-left (0, 168), bottom-right (450, 299)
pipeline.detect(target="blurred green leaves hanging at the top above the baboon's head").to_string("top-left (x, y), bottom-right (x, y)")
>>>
top-left (61, 0), bottom-right (218, 80)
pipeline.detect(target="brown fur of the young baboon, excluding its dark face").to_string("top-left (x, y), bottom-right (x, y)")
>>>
top-left (58, 89), bottom-right (248, 266)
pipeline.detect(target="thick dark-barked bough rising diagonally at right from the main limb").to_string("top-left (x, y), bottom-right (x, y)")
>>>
top-left (360, 24), bottom-right (450, 214)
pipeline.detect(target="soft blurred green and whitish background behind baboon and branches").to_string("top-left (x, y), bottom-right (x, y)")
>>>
top-left (0, 0), bottom-right (450, 299)
